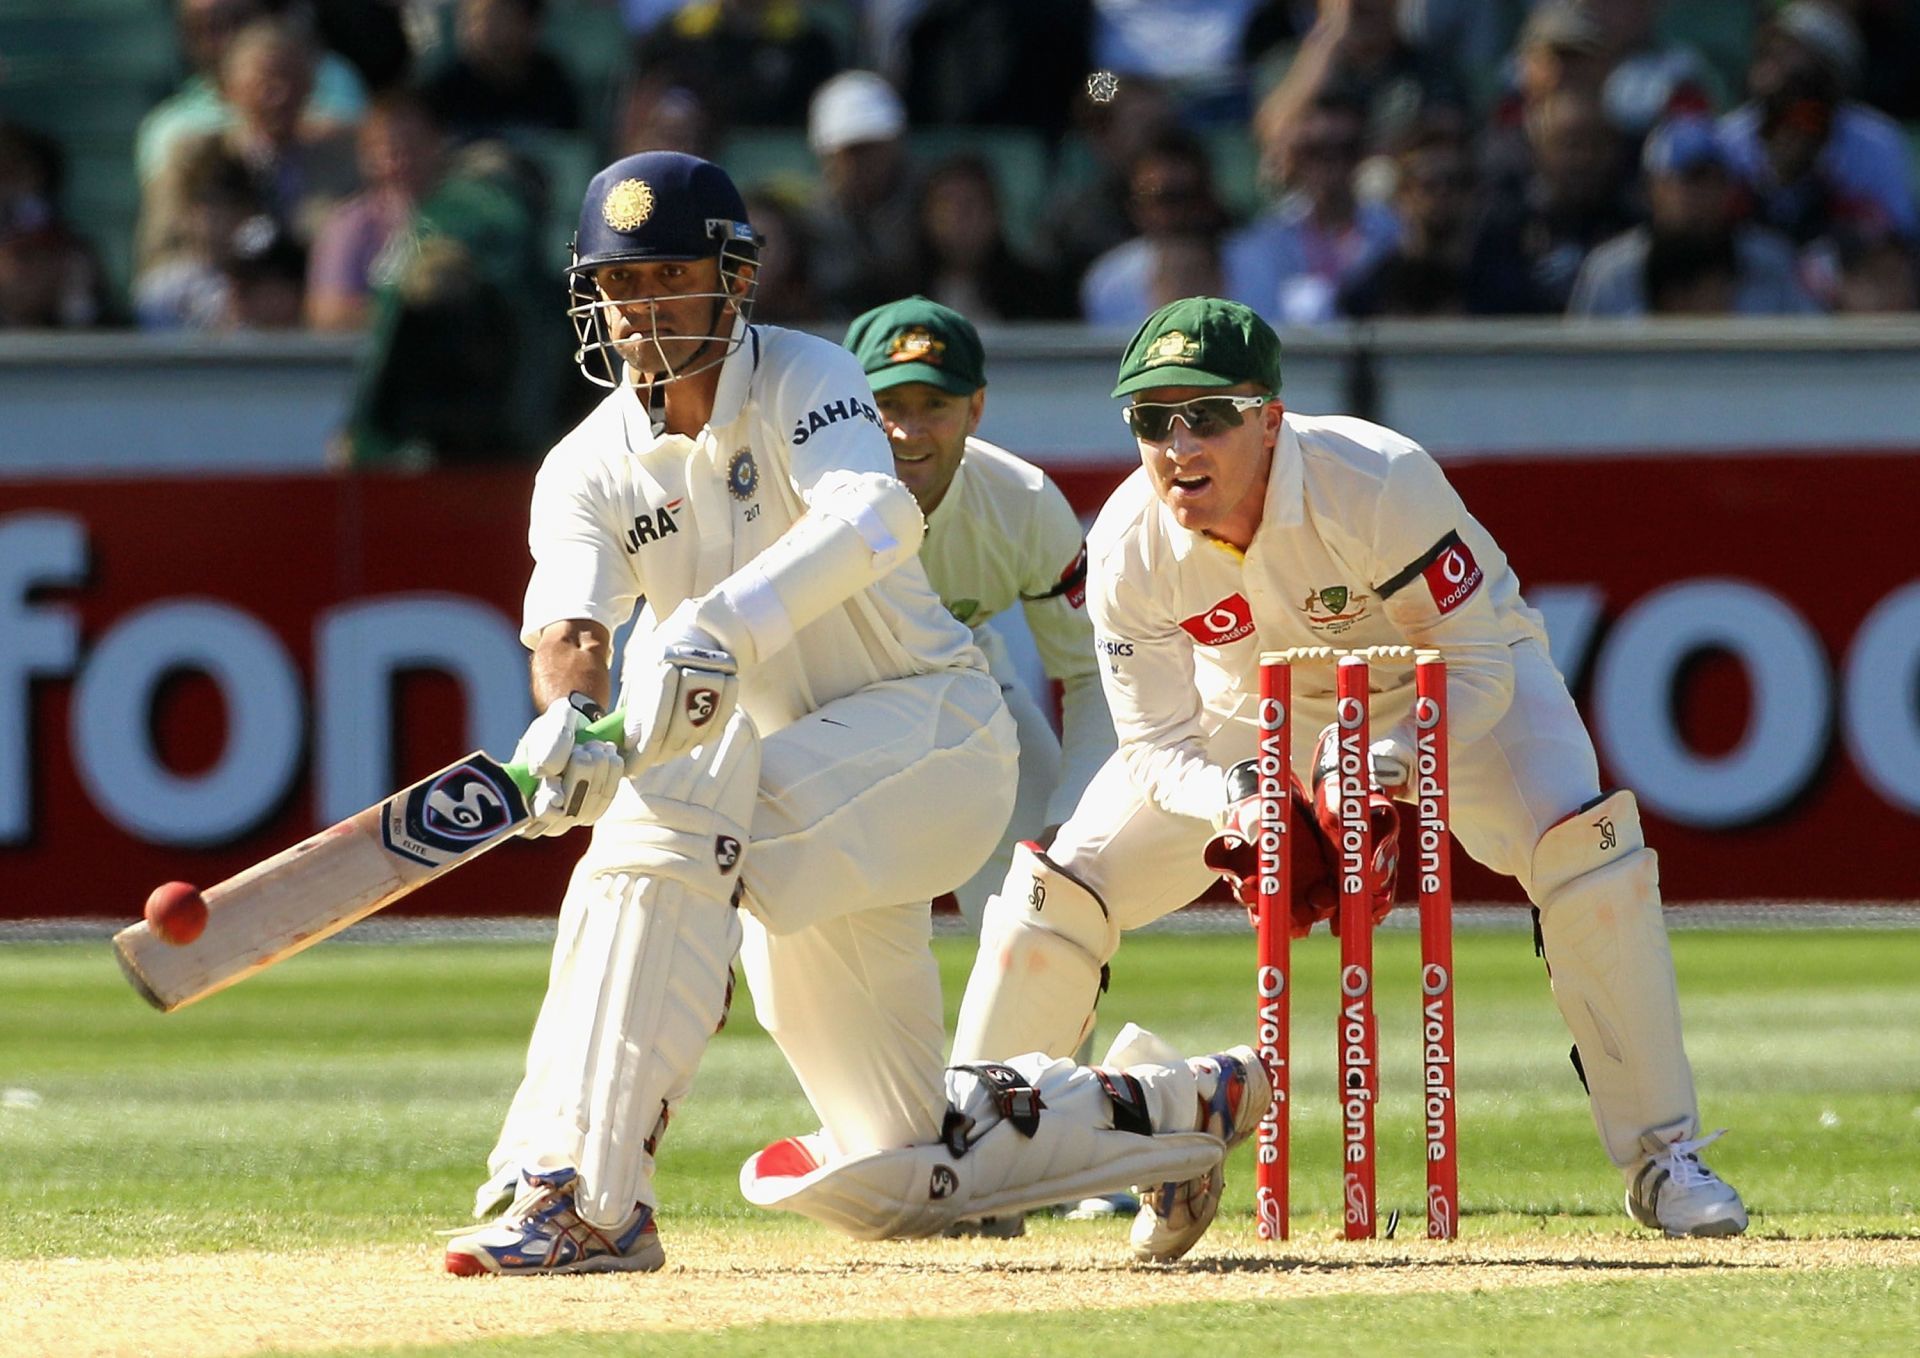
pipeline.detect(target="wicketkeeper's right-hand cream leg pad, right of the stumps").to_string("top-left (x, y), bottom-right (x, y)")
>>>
top-left (1534, 791), bottom-right (1699, 1168)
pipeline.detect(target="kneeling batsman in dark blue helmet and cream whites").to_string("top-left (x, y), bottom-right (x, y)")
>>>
top-left (445, 152), bottom-right (1273, 1273)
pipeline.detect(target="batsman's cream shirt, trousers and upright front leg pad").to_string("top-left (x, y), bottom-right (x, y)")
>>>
top-left (492, 327), bottom-right (1016, 1220)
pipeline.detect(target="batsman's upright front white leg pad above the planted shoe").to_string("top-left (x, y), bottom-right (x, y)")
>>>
top-left (490, 715), bottom-right (760, 1225)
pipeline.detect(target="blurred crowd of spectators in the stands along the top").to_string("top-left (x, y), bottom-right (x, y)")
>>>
top-left (11, 0), bottom-right (1920, 457)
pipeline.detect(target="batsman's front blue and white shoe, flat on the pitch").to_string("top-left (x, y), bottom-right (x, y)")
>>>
top-left (447, 1170), bottom-right (666, 1277)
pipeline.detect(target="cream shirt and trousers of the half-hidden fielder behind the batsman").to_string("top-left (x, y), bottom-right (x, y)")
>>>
top-left (920, 438), bottom-right (1114, 930)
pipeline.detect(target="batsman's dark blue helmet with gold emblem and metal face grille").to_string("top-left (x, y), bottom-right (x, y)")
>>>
top-left (566, 152), bottom-right (760, 386)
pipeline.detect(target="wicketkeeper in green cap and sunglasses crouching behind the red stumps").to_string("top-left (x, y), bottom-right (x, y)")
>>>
top-left (952, 298), bottom-right (1747, 1262)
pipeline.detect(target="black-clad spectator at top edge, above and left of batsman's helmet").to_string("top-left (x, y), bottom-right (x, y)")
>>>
top-left (422, 0), bottom-right (580, 142)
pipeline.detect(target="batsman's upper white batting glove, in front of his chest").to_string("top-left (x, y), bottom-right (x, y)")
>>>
top-left (622, 599), bottom-right (739, 778)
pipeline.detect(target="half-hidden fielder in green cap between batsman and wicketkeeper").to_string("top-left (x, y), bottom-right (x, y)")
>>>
top-left (845, 298), bottom-right (1114, 934)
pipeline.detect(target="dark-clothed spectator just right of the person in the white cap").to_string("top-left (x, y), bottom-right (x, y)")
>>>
top-left (912, 154), bottom-right (1075, 321)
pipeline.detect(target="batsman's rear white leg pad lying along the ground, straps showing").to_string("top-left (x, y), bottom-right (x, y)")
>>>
top-left (739, 1053), bottom-right (1223, 1241)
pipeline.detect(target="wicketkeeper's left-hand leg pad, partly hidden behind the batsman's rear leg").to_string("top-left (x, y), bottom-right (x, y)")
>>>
top-left (954, 843), bottom-right (1119, 1064)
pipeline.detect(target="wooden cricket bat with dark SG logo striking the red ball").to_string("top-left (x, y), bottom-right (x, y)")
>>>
top-left (113, 711), bottom-right (624, 1014)
